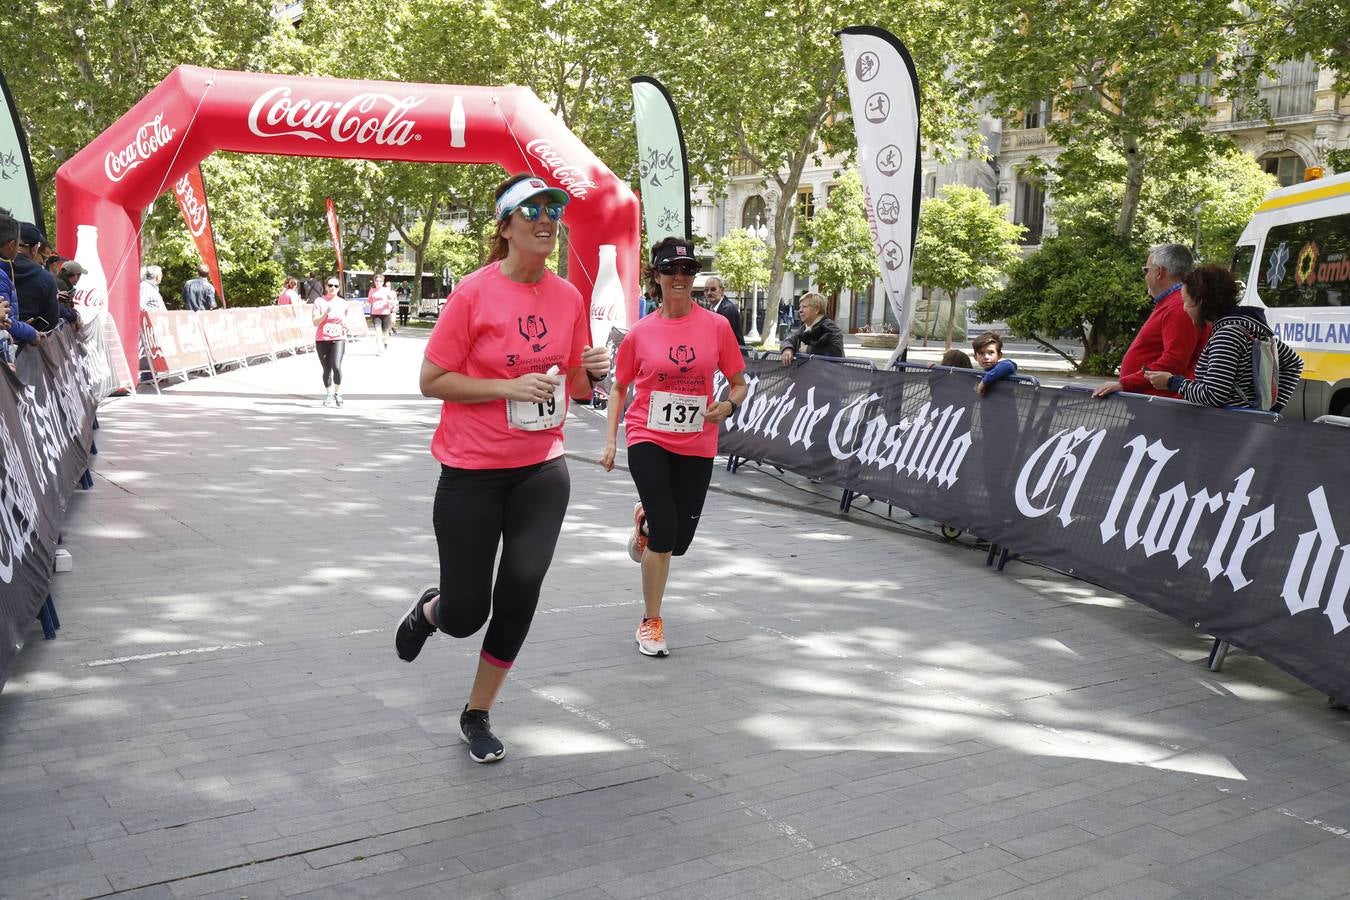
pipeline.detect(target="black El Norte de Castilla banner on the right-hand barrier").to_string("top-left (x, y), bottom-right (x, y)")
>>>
top-left (718, 359), bottom-right (1350, 698)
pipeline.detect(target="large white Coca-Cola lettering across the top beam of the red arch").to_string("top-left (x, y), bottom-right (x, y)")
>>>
top-left (248, 88), bottom-right (425, 147)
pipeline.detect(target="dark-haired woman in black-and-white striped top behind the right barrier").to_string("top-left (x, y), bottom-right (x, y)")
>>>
top-left (1145, 266), bottom-right (1303, 413)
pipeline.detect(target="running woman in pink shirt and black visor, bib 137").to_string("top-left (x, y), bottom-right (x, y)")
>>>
top-left (601, 237), bottom-right (748, 656)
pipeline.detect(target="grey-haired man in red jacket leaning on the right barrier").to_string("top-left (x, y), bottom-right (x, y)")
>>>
top-left (1092, 244), bottom-right (1211, 397)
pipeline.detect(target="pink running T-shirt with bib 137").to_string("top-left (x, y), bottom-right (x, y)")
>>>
top-left (614, 305), bottom-right (745, 457)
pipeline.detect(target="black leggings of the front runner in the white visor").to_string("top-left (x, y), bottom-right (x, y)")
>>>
top-left (432, 456), bottom-right (571, 669)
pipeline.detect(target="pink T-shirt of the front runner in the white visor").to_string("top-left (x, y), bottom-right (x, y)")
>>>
top-left (427, 263), bottom-right (590, 468)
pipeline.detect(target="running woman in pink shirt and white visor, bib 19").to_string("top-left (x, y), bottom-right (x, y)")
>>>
top-left (394, 175), bottom-right (609, 762)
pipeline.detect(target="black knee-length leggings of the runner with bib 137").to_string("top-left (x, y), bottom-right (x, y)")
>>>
top-left (628, 441), bottom-right (713, 556)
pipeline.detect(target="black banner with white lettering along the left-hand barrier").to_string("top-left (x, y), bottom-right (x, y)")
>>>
top-left (0, 325), bottom-right (99, 688)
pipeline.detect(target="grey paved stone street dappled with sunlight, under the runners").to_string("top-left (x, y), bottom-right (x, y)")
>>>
top-left (0, 333), bottom-right (1350, 900)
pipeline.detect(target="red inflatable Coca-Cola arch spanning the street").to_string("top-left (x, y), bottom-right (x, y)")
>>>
top-left (57, 66), bottom-right (640, 371)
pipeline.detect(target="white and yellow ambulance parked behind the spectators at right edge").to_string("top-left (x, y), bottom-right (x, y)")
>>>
top-left (1231, 173), bottom-right (1350, 420)
